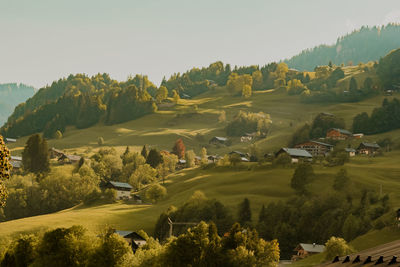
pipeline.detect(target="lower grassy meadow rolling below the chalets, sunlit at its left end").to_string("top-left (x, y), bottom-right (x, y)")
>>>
top-left (0, 151), bottom-right (400, 241)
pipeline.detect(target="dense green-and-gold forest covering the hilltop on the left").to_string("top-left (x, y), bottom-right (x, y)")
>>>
top-left (1, 74), bottom-right (156, 138)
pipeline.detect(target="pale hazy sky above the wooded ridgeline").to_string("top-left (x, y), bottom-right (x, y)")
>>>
top-left (0, 0), bottom-right (400, 88)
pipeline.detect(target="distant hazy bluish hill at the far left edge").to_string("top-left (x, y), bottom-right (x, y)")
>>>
top-left (0, 83), bottom-right (35, 125)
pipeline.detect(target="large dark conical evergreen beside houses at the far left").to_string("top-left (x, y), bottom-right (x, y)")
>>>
top-left (22, 134), bottom-right (50, 174)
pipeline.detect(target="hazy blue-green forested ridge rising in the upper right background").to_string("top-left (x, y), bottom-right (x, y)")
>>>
top-left (285, 24), bottom-right (400, 71)
